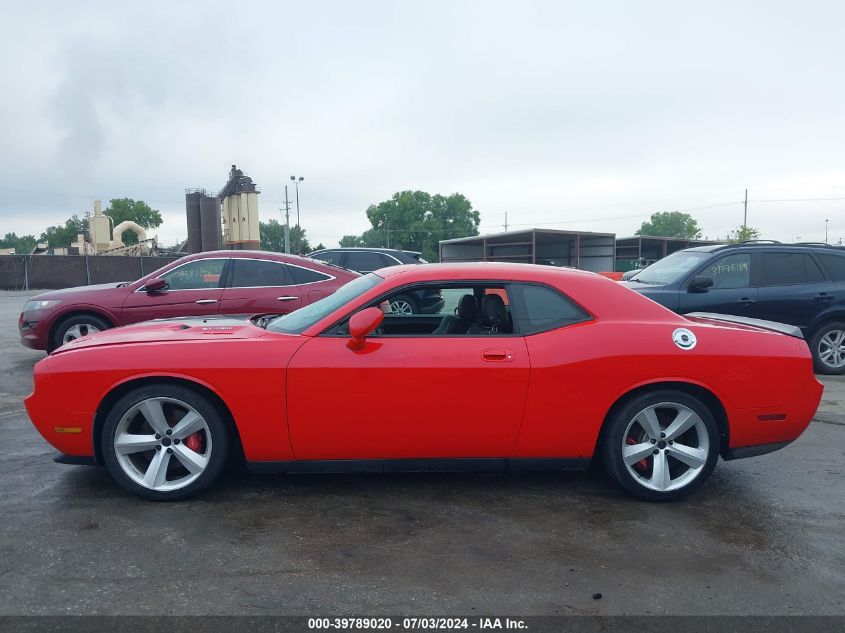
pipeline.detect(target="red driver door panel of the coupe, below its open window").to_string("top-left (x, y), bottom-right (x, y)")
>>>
top-left (287, 286), bottom-right (530, 460)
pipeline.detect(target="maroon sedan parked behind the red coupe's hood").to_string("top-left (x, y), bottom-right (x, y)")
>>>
top-left (18, 251), bottom-right (359, 351)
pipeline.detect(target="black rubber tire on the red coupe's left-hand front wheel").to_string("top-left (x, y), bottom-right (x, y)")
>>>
top-left (100, 383), bottom-right (230, 501)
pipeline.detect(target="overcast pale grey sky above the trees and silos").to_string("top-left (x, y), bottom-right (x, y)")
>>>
top-left (0, 0), bottom-right (845, 246)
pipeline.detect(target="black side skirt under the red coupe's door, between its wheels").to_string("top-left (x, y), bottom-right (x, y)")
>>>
top-left (247, 457), bottom-right (590, 474)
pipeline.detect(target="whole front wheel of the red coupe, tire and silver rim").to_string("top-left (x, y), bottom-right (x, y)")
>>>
top-left (101, 384), bottom-right (228, 501)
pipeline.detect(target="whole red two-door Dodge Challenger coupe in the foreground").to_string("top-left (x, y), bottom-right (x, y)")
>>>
top-left (26, 263), bottom-right (822, 500)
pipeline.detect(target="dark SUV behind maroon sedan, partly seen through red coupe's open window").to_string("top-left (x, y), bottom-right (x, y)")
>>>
top-left (308, 247), bottom-right (443, 314)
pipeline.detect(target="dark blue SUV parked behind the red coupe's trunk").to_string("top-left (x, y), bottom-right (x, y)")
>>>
top-left (623, 242), bottom-right (845, 374)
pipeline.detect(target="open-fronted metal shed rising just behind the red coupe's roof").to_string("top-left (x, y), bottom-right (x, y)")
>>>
top-left (440, 229), bottom-right (616, 272)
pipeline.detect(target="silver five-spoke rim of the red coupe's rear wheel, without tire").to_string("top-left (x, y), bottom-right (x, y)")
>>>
top-left (622, 402), bottom-right (710, 492)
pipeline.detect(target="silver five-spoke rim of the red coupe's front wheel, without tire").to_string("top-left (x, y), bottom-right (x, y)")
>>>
top-left (114, 397), bottom-right (212, 492)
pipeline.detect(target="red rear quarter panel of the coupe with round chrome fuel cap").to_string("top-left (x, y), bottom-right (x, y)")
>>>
top-left (514, 320), bottom-right (821, 457)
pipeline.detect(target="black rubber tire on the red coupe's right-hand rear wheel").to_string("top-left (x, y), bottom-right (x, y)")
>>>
top-left (601, 390), bottom-right (720, 501)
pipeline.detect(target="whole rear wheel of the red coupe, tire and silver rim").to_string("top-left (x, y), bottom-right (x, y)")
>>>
top-left (603, 390), bottom-right (719, 501)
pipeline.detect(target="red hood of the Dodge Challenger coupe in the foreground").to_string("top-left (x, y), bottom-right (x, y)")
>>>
top-left (53, 316), bottom-right (276, 354)
